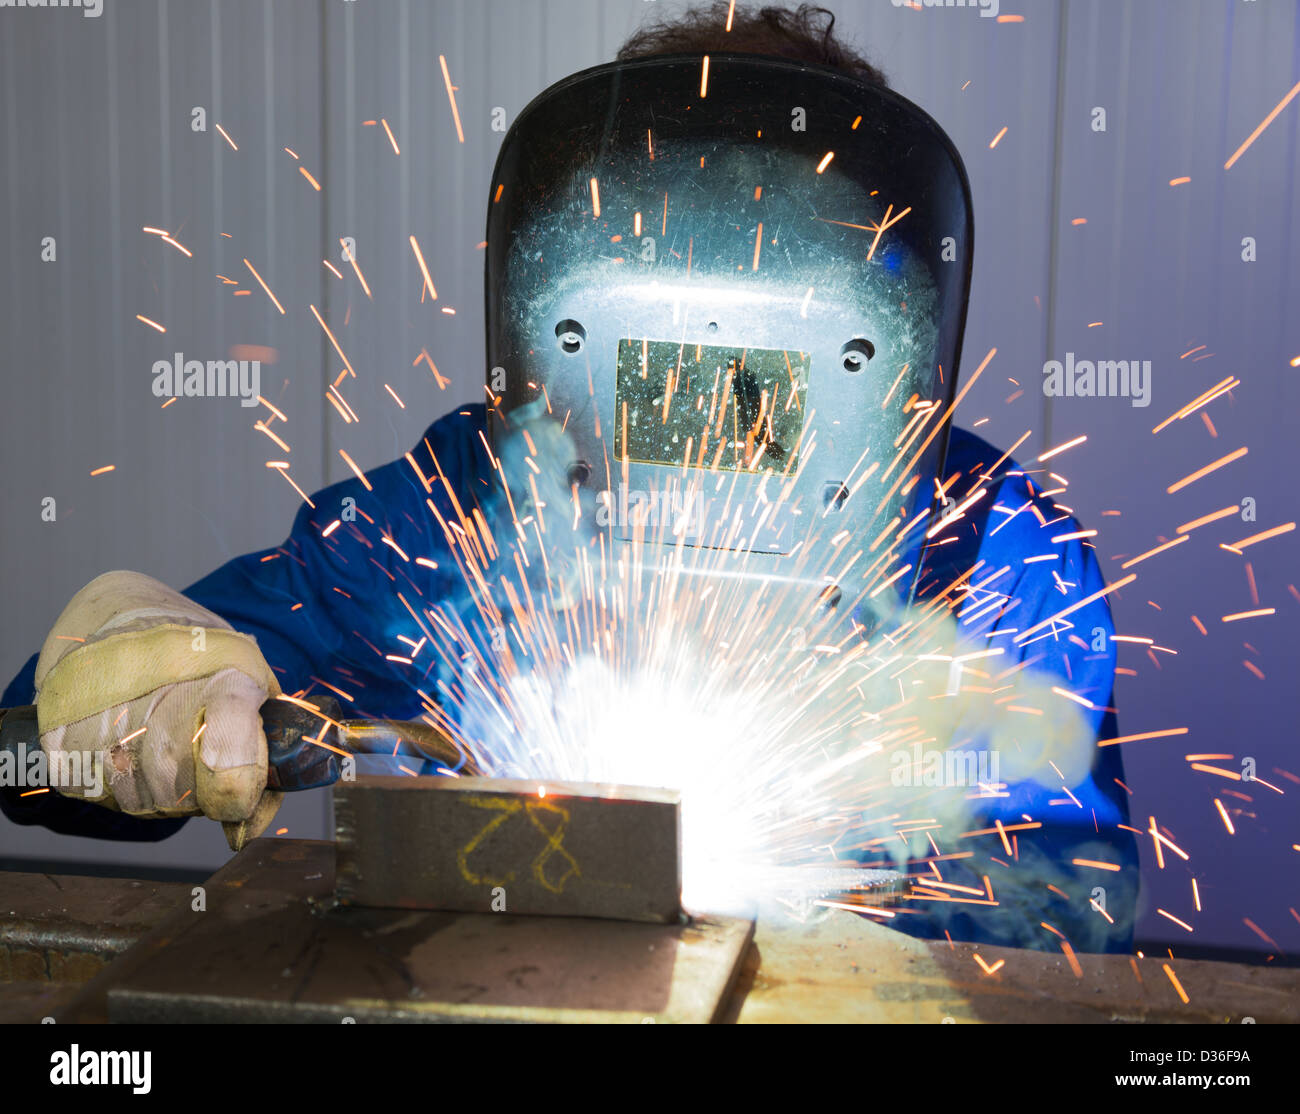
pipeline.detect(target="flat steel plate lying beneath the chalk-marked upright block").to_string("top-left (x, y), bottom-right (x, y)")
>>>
top-left (55, 840), bottom-right (754, 1024)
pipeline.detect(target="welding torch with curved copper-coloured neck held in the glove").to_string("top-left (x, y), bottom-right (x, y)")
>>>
top-left (0, 697), bottom-right (481, 793)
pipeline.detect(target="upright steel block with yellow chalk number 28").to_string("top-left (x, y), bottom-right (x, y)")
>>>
top-left (334, 777), bottom-right (681, 923)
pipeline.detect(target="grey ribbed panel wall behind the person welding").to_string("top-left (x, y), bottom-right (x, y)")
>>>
top-left (0, 0), bottom-right (1300, 950)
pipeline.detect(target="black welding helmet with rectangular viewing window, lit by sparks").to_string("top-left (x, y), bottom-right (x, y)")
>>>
top-left (486, 55), bottom-right (972, 608)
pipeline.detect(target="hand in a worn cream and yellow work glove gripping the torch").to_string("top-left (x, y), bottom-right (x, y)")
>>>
top-left (35, 572), bottom-right (283, 850)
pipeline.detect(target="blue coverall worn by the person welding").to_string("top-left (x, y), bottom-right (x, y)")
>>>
top-left (0, 406), bottom-right (1138, 952)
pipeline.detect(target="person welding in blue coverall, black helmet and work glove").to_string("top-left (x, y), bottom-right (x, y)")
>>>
top-left (0, 3), bottom-right (1136, 952)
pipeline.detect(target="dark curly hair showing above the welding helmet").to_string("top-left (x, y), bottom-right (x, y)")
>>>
top-left (618, 0), bottom-right (889, 88)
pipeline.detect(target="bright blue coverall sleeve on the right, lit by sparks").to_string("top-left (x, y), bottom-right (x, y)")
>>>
top-left (892, 447), bottom-right (1138, 952)
